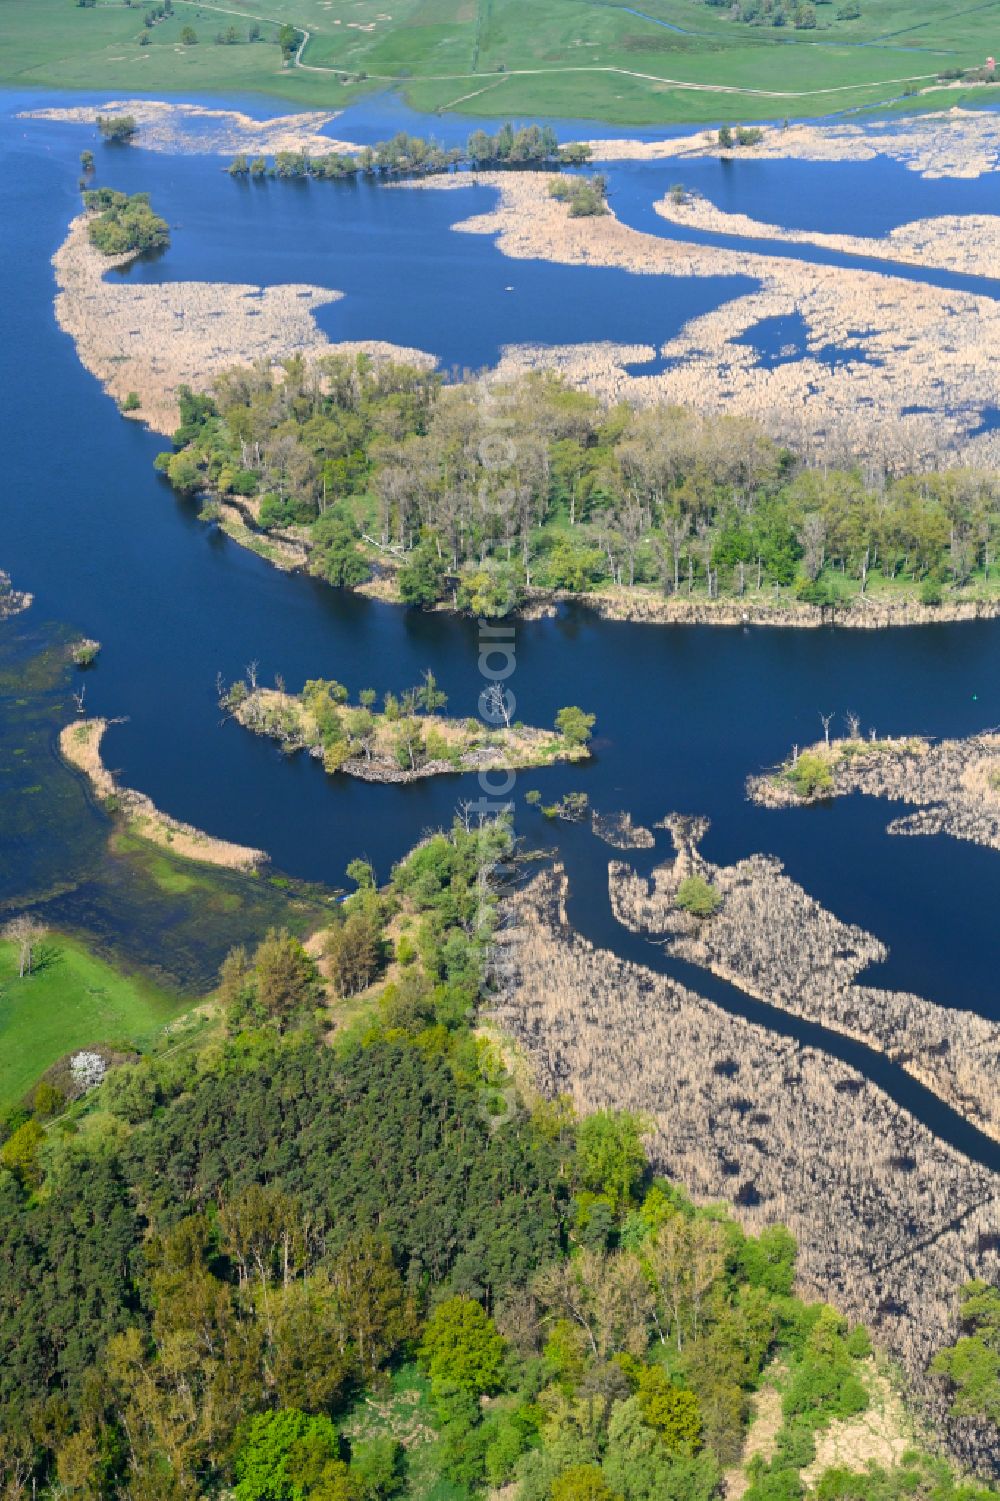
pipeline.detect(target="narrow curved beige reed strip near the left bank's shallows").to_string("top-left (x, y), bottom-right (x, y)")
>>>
top-left (59, 719), bottom-right (267, 875)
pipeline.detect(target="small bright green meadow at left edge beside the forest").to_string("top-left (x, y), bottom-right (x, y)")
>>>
top-left (0, 934), bottom-right (184, 1109)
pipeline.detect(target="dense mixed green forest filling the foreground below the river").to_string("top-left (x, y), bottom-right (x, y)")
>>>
top-left (0, 824), bottom-right (1000, 1501)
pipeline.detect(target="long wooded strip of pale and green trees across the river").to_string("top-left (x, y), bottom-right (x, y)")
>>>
top-left (158, 356), bottom-right (1000, 614)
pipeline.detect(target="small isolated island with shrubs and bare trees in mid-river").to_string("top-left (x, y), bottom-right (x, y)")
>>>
top-left (221, 668), bottom-right (595, 782)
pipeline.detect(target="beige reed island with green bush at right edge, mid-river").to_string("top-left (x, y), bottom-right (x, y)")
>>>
top-left (746, 722), bottom-right (1000, 850)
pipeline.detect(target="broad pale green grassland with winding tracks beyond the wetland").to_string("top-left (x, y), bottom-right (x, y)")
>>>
top-left (0, 0), bottom-right (1000, 123)
